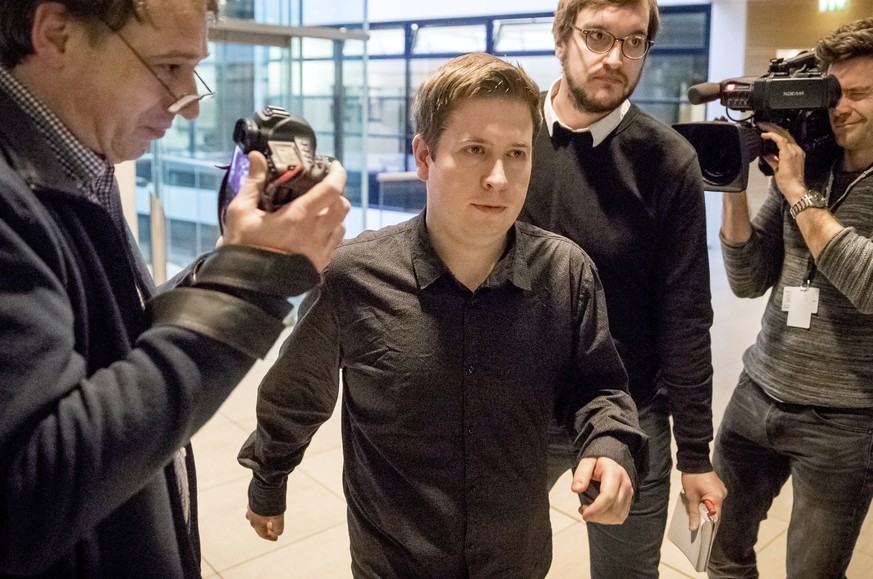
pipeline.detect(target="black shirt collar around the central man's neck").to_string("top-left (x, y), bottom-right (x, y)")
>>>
top-left (411, 209), bottom-right (532, 290)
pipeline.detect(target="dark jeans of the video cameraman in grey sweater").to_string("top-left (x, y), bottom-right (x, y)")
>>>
top-left (709, 372), bottom-right (873, 579)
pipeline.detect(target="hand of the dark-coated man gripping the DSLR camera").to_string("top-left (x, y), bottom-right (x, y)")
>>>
top-left (222, 152), bottom-right (351, 274)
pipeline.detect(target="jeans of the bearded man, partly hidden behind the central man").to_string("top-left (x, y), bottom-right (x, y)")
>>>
top-left (549, 393), bottom-right (673, 579)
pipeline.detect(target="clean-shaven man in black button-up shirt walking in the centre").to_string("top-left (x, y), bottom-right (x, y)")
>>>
top-left (240, 54), bottom-right (647, 578)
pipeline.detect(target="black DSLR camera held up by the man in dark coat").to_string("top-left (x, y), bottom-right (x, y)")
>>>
top-left (218, 106), bottom-right (333, 226)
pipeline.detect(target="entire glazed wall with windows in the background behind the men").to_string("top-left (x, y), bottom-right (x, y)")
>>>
top-left (136, 0), bottom-right (710, 275)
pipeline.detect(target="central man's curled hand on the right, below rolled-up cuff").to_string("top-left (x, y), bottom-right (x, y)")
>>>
top-left (570, 456), bottom-right (634, 525)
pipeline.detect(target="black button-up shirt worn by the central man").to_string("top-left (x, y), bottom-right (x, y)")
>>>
top-left (240, 215), bottom-right (646, 578)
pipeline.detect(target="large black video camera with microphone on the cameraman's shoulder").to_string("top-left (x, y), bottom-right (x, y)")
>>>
top-left (673, 50), bottom-right (840, 192)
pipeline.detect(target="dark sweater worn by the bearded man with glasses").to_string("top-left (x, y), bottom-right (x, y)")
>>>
top-left (520, 106), bottom-right (712, 473)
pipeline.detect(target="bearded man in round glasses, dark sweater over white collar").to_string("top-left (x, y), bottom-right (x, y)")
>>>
top-left (520, 0), bottom-right (726, 579)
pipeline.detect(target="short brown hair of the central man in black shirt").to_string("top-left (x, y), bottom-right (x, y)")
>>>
top-left (412, 52), bottom-right (542, 154)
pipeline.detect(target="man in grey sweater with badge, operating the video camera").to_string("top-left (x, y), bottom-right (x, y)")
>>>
top-left (709, 18), bottom-right (873, 579)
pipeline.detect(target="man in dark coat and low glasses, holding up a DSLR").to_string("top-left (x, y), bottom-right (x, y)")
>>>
top-left (0, 0), bottom-right (348, 579)
